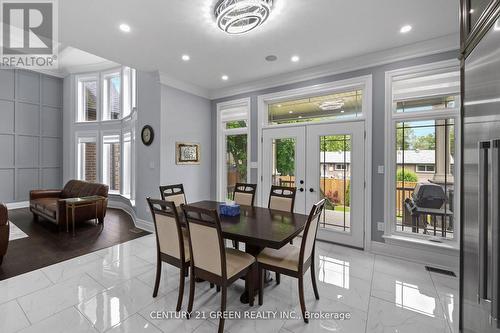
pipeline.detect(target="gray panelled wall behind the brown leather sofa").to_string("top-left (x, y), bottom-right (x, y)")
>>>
top-left (0, 69), bottom-right (63, 202)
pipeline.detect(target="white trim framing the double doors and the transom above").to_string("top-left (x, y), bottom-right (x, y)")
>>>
top-left (256, 74), bottom-right (373, 251)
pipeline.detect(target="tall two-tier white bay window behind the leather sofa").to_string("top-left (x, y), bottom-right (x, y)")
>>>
top-left (74, 67), bottom-right (137, 200)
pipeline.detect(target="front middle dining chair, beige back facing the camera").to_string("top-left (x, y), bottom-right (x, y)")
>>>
top-left (181, 205), bottom-right (256, 333)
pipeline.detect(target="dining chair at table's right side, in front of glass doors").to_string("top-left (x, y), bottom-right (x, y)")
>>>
top-left (257, 199), bottom-right (325, 323)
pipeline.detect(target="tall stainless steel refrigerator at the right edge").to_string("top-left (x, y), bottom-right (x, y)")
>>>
top-left (460, 13), bottom-right (500, 333)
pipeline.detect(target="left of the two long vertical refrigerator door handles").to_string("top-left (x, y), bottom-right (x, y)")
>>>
top-left (477, 141), bottom-right (491, 303)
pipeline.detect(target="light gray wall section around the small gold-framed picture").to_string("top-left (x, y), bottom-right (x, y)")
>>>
top-left (161, 85), bottom-right (215, 202)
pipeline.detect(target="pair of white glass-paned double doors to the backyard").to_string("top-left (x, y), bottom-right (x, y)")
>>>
top-left (261, 122), bottom-right (365, 248)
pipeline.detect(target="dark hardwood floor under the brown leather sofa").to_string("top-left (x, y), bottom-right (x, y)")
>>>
top-left (0, 208), bottom-right (149, 281)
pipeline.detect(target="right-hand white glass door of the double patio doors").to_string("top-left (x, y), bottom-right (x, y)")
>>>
top-left (306, 122), bottom-right (365, 248)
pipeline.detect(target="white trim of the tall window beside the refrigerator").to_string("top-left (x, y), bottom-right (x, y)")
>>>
top-left (383, 60), bottom-right (461, 249)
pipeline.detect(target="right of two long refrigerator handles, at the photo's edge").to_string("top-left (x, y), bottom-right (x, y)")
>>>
top-left (490, 140), bottom-right (500, 327)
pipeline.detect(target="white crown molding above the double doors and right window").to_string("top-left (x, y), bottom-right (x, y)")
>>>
top-left (209, 34), bottom-right (460, 99)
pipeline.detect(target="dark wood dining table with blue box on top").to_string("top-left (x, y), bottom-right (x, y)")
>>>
top-left (184, 200), bottom-right (307, 303)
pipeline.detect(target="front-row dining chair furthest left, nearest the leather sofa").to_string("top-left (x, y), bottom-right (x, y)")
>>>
top-left (146, 198), bottom-right (191, 311)
